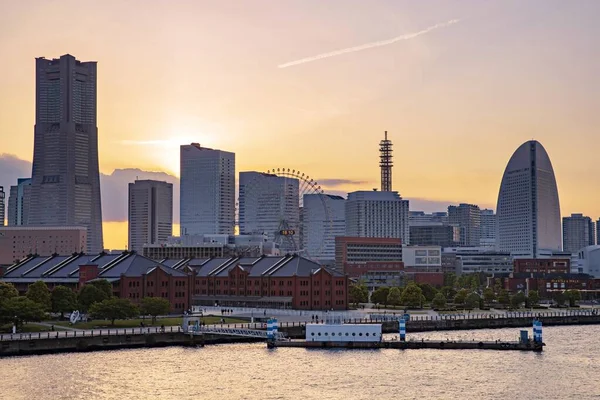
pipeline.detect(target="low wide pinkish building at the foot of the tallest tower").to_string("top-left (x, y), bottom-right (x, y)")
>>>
top-left (0, 226), bottom-right (88, 265)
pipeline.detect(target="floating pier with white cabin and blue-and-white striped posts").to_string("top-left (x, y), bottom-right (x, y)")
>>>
top-left (267, 319), bottom-right (545, 352)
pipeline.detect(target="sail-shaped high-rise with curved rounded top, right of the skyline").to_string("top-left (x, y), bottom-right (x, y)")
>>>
top-left (496, 140), bottom-right (561, 258)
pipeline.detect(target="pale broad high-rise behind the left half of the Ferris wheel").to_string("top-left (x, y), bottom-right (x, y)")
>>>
top-left (239, 171), bottom-right (302, 254)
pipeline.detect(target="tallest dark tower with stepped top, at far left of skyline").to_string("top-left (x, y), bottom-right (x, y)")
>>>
top-left (28, 54), bottom-right (103, 253)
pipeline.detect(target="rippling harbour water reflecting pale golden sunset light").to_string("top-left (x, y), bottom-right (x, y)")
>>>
top-left (0, 326), bottom-right (600, 400)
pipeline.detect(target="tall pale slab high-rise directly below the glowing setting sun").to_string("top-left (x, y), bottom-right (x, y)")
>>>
top-left (180, 143), bottom-right (235, 235)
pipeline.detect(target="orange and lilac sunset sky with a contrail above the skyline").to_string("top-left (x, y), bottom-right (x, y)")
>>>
top-left (0, 0), bottom-right (600, 248)
